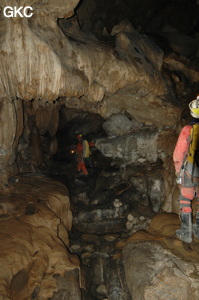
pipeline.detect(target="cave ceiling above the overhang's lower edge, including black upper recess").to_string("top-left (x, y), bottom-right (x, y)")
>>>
top-left (0, 0), bottom-right (199, 108)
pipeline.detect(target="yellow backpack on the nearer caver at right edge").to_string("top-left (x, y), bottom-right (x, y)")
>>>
top-left (187, 123), bottom-right (199, 167)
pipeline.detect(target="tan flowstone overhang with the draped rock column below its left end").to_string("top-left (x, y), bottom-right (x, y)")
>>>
top-left (0, 0), bottom-right (179, 195)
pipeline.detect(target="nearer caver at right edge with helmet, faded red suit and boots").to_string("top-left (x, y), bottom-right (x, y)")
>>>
top-left (173, 97), bottom-right (199, 243)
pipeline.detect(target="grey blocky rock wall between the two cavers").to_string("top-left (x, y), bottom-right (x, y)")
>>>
top-left (93, 114), bottom-right (178, 212)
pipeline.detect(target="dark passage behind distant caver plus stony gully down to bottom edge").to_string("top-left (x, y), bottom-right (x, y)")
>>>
top-left (45, 108), bottom-right (155, 299)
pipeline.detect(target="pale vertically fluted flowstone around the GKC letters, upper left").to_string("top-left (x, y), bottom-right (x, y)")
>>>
top-left (0, 0), bottom-right (83, 100)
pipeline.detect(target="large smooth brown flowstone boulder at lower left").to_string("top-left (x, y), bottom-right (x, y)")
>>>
top-left (0, 175), bottom-right (80, 300)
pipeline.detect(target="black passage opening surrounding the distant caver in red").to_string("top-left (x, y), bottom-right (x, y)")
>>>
top-left (49, 109), bottom-right (132, 216)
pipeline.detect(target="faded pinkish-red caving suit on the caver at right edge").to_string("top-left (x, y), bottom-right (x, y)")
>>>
top-left (173, 125), bottom-right (198, 213)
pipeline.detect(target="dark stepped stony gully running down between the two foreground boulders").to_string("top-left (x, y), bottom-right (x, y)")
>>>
top-left (48, 150), bottom-right (155, 300)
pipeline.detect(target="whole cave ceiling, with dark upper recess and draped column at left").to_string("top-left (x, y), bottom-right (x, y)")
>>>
top-left (0, 0), bottom-right (199, 188)
